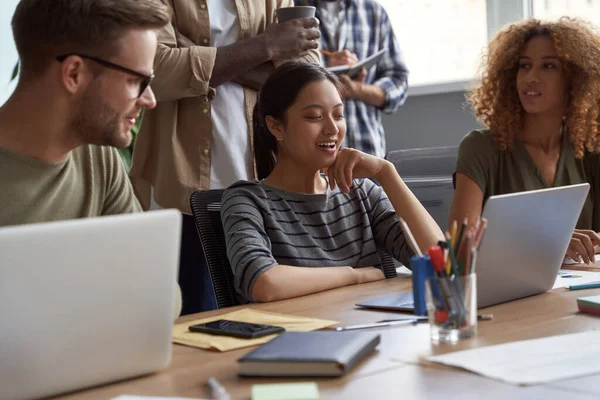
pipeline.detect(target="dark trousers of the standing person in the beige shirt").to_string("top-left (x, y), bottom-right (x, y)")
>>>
top-left (179, 214), bottom-right (217, 315)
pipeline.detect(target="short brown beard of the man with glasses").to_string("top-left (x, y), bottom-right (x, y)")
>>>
top-left (72, 85), bottom-right (131, 148)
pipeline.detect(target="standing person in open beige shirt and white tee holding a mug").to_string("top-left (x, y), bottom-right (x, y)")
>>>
top-left (131, 0), bottom-right (320, 314)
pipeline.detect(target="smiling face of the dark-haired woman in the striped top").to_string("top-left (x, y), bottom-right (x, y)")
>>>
top-left (271, 79), bottom-right (346, 170)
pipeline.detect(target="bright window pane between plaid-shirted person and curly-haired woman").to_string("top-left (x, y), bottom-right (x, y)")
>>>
top-left (378, 0), bottom-right (488, 87)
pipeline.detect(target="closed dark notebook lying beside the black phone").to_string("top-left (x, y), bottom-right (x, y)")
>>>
top-left (238, 331), bottom-right (380, 376)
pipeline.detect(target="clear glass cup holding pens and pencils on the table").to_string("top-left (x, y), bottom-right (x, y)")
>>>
top-left (425, 274), bottom-right (477, 343)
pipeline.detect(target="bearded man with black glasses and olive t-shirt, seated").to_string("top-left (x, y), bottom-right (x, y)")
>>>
top-left (0, 0), bottom-right (170, 226)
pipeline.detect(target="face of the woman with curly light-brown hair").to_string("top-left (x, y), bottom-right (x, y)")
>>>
top-left (517, 36), bottom-right (567, 115)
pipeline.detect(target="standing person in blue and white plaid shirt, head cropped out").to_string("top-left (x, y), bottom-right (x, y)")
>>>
top-left (294, 0), bottom-right (408, 157)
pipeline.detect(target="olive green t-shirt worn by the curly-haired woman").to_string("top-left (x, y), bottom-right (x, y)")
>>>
top-left (455, 130), bottom-right (600, 232)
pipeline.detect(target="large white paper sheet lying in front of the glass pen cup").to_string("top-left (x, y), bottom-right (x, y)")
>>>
top-left (427, 331), bottom-right (600, 385)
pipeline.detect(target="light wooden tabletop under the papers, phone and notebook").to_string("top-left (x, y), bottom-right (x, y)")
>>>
top-left (52, 278), bottom-right (600, 400)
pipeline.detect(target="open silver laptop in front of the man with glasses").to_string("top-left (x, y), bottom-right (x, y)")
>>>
top-left (0, 210), bottom-right (181, 400)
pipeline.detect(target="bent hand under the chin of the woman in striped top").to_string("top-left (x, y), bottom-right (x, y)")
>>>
top-left (327, 148), bottom-right (394, 193)
